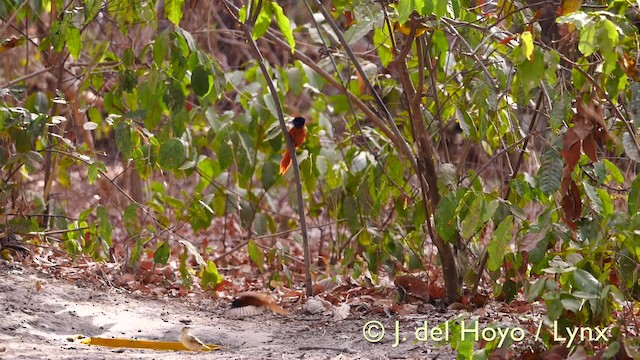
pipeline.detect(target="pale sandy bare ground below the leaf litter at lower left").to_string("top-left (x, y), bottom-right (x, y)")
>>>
top-left (0, 260), bottom-right (455, 360)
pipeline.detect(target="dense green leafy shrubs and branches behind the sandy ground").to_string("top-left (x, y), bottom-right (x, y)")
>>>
top-left (0, 0), bottom-right (640, 354)
